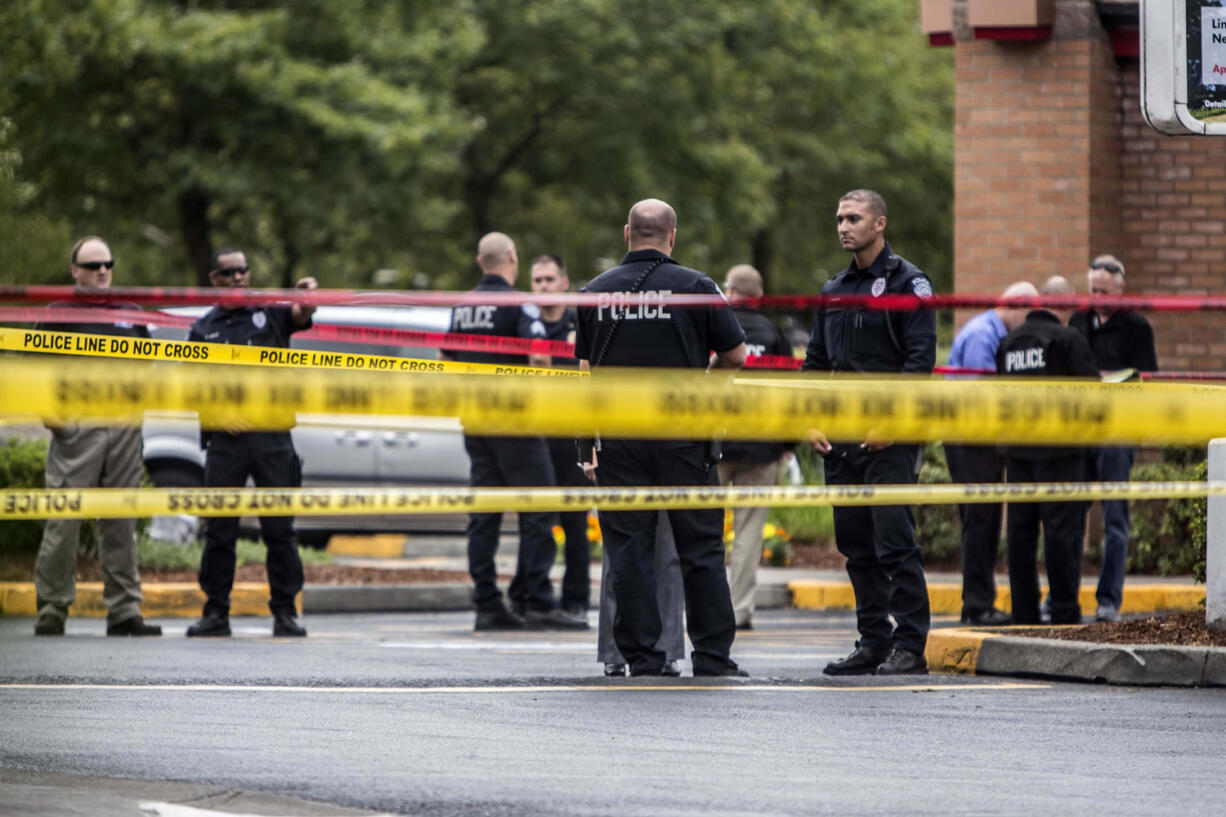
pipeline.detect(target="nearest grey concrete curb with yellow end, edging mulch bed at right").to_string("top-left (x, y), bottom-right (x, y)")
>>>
top-left (926, 629), bottom-right (1226, 687)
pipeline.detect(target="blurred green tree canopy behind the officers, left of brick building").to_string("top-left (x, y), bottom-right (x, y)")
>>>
top-left (0, 0), bottom-right (953, 292)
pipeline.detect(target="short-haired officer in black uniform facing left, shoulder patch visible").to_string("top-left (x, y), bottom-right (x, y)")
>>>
top-left (803, 190), bottom-right (937, 675)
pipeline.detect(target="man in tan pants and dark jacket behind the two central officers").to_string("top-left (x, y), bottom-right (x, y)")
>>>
top-left (720, 264), bottom-right (792, 629)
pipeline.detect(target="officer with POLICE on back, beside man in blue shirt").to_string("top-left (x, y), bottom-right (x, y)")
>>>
top-left (997, 276), bottom-right (1100, 624)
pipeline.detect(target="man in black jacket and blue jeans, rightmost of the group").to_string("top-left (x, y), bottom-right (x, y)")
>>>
top-left (1069, 255), bottom-right (1157, 621)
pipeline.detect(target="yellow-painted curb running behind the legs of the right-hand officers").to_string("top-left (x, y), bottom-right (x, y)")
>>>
top-left (787, 579), bottom-right (1205, 618)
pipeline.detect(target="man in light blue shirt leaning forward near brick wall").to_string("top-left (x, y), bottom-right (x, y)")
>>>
top-left (945, 281), bottom-right (1038, 626)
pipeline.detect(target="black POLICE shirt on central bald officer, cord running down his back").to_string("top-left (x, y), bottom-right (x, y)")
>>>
top-left (575, 249), bottom-right (745, 369)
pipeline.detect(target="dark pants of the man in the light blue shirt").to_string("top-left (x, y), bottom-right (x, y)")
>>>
top-left (945, 443), bottom-right (1004, 613)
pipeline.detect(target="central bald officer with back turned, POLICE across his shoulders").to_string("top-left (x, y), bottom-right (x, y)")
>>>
top-left (575, 199), bottom-right (748, 676)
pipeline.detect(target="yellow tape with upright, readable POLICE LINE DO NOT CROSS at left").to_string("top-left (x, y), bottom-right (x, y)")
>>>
top-left (0, 326), bottom-right (586, 378)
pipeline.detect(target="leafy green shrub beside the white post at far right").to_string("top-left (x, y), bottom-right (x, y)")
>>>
top-left (1123, 453), bottom-right (1209, 581)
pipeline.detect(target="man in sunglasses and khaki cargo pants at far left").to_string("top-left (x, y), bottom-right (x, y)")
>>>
top-left (34, 236), bottom-right (162, 635)
